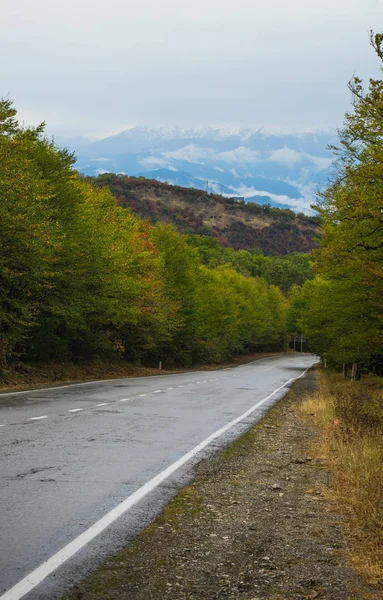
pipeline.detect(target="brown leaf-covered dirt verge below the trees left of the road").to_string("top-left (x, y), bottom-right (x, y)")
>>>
top-left (0, 352), bottom-right (282, 399)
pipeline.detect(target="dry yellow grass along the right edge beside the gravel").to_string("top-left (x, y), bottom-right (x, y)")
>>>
top-left (299, 371), bottom-right (383, 586)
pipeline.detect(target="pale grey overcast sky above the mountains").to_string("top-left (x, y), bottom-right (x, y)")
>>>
top-left (0, 0), bottom-right (383, 137)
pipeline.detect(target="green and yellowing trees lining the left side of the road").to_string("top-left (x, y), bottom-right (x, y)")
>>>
top-left (0, 100), bottom-right (311, 368)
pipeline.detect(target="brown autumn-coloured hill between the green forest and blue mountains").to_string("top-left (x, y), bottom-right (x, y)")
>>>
top-left (91, 173), bottom-right (319, 256)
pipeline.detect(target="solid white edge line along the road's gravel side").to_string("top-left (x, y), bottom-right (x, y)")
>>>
top-left (0, 367), bottom-right (310, 600)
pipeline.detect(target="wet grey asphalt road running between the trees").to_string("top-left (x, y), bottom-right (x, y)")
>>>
top-left (0, 354), bottom-right (316, 600)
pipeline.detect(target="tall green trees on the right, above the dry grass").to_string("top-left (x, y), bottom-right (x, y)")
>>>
top-left (289, 34), bottom-right (383, 379)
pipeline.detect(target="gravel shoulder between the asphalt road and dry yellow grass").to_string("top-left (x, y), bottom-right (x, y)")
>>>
top-left (66, 371), bottom-right (382, 600)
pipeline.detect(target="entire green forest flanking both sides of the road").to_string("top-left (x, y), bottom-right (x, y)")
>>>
top-left (0, 34), bottom-right (383, 379)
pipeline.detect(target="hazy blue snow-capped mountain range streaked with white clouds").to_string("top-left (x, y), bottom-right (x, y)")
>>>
top-left (58, 126), bottom-right (335, 214)
